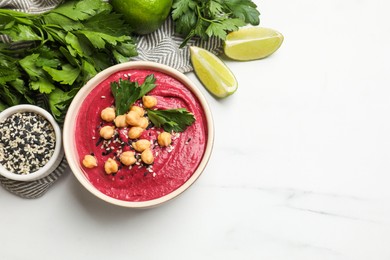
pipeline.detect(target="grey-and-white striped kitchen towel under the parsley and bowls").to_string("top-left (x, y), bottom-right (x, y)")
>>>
top-left (0, 0), bottom-right (222, 198)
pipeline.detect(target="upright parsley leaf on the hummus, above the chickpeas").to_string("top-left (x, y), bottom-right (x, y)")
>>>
top-left (111, 74), bottom-right (156, 115)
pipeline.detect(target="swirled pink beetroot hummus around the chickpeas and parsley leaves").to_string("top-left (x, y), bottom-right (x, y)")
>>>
top-left (75, 69), bottom-right (208, 201)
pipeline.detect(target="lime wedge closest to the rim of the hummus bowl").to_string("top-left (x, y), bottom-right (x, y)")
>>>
top-left (190, 46), bottom-right (238, 98)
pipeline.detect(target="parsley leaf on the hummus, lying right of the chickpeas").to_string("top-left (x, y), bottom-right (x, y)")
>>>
top-left (146, 108), bottom-right (195, 132)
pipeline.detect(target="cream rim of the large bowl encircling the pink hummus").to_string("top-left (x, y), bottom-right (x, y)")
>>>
top-left (63, 61), bottom-right (214, 208)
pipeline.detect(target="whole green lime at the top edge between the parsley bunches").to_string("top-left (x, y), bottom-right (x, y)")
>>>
top-left (110, 0), bottom-right (173, 34)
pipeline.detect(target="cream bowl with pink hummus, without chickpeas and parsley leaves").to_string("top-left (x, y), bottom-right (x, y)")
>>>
top-left (63, 61), bottom-right (214, 208)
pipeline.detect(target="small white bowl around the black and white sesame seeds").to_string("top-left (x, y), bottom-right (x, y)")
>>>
top-left (0, 105), bottom-right (64, 181)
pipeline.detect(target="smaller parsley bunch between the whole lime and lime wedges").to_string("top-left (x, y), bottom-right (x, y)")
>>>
top-left (172, 0), bottom-right (260, 46)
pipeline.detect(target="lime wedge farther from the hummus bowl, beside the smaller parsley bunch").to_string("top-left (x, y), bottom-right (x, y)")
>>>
top-left (223, 27), bottom-right (284, 61)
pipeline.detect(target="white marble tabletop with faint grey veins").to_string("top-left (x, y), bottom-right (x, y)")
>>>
top-left (0, 0), bottom-right (390, 260)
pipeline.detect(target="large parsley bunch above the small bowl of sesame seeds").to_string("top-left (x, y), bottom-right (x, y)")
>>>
top-left (0, 0), bottom-right (137, 122)
